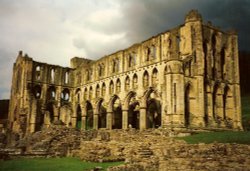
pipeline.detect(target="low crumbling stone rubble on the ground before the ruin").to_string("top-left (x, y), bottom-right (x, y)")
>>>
top-left (2, 127), bottom-right (250, 171)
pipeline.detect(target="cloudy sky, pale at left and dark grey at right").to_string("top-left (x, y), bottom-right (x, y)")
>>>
top-left (0, 0), bottom-right (250, 99)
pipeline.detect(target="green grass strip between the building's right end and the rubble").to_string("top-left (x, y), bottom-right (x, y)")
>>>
top-left (177, 131), bottom-right (250, 144)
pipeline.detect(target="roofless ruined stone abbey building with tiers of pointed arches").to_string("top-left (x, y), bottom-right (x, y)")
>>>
top-left (9, 10), bottom-right (242, 134)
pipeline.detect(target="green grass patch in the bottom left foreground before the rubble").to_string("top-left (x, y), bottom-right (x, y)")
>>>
top-left (0, 157), bottom-right (123, 171)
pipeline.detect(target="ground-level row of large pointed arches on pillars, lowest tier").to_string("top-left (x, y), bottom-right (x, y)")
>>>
top-left (76, 90), bottom-right (161, 129)
